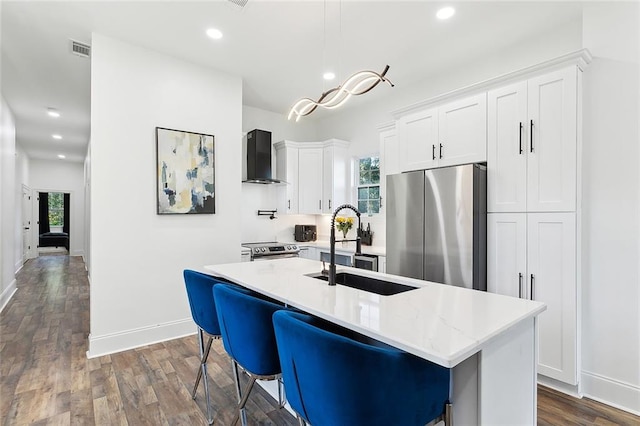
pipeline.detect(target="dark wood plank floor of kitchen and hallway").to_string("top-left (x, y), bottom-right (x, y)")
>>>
top-left (0, 256), bottom-right (640, 425)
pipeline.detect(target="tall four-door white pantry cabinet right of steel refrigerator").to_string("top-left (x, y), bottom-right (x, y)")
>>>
top-left (487, 65), bottom-right (581, 386)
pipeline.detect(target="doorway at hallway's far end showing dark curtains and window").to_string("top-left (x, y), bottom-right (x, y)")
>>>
top-left (38, 192), bottom-right (70, 254)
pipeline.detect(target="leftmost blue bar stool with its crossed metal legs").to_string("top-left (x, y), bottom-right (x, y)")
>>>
top-left (183, 269), bottom-right (226, 424)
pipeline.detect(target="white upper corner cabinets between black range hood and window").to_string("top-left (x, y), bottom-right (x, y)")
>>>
top-left (275, 139), bottom-right (350, 214)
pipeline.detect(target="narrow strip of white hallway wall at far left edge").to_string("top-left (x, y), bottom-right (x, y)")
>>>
top-left (0, 93), bottom-right (17, 310)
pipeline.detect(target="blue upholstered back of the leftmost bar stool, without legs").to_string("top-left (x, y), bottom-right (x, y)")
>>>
top-left (183, 269), bottom-right (220, 336)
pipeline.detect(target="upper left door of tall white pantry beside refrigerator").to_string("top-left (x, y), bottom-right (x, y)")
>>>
top-left (487, 82), bottom-right (528, 212)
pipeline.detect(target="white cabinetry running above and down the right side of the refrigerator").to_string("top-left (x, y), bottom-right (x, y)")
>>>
top-left (379, 49), bottom-right (592, 392)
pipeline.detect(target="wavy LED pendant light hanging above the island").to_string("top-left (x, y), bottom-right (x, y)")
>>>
top-left (288, 0), bottom-right (393, 121)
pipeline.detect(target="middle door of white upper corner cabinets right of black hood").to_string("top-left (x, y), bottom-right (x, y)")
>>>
top-left (298, 148), bottom-right (322, 214)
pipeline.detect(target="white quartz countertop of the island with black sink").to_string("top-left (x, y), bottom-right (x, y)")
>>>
top-left (204, 258), bottom-right (546, 368)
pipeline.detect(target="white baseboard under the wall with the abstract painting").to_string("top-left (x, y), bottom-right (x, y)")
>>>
top-left (87, 318), bottom-right (196, 358)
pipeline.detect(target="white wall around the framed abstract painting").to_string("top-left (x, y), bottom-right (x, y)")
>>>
top-left (89, 34), bottom-right (242, 356)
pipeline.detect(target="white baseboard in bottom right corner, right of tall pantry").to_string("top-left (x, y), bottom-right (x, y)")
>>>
top-left (581, 371), bottom-right (640, 416)
